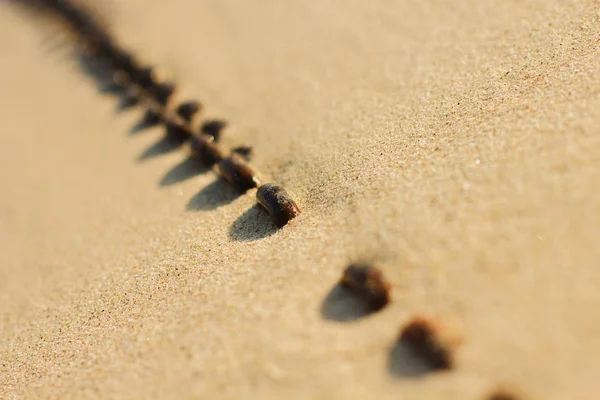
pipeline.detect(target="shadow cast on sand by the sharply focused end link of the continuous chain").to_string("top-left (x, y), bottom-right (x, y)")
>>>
top-left (229, 204), bottom-right (279, 242)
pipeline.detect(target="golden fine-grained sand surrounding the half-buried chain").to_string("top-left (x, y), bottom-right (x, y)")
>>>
top-left (0, 0), bottom-right (600, 400)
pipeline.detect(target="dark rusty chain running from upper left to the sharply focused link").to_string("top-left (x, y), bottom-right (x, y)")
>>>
top-left (32, 0), bottom-right (300, 227)
